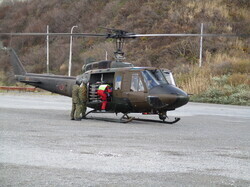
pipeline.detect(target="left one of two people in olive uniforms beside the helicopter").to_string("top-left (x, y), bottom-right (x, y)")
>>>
top-left (70, 79), bottom-right (82, 121)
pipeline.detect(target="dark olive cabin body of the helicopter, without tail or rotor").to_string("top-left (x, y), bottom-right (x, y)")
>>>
top-left (83, 67), bottom-right (189, 113)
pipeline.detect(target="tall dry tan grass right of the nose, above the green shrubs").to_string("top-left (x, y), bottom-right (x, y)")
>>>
top-left (176, 49), bottom-right (250, 95)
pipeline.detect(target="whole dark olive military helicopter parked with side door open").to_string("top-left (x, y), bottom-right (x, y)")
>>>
top-left (0, 29), bottom-right (246, 124)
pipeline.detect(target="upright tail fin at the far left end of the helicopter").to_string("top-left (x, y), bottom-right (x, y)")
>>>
top-left (9, 48), bottom-right (26, 75)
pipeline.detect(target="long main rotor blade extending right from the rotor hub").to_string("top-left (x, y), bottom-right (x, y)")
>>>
top-left (130, 34), bottom-right (250, 38)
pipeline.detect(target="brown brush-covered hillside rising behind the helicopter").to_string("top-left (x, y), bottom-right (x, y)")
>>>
top-left (0, 0), bottom-right (250, 104)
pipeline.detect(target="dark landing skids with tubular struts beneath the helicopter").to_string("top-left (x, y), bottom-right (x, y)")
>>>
top-left (84, 110), bottom-right (181, 124)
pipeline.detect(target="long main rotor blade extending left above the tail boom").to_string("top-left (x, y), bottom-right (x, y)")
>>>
top-left (0, 33), bottom-right (107, 37)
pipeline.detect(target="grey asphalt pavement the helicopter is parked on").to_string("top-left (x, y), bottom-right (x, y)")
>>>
top-left (0, 93), bottom-right (250, 186)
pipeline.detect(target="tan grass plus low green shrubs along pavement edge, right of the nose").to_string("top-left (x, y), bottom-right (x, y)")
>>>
top-left (176, 51), bottom-right (250, 106)
